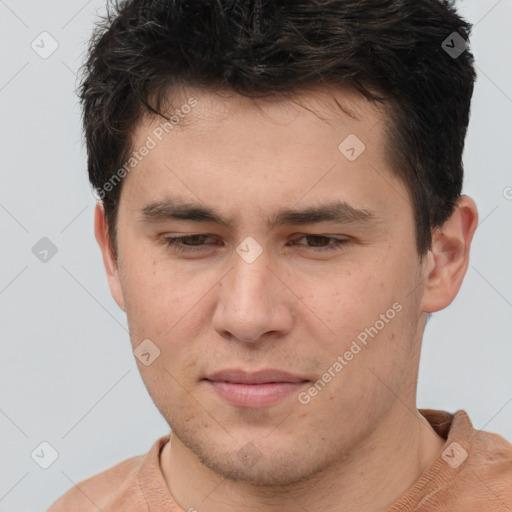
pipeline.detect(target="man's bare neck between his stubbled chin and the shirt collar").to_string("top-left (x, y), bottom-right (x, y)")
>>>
top-left (161, 401), bottom-right (445, 512)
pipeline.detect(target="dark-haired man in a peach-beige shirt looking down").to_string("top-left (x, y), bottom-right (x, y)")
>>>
top-left (46, 0), bottom-right (512, 512)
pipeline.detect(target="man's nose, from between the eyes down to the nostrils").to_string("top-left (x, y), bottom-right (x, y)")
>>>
top-left (212, 243), bottom-right (295, 343)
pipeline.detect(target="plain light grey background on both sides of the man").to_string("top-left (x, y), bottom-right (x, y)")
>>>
top-left (0, 0), bottom-right (512, 512)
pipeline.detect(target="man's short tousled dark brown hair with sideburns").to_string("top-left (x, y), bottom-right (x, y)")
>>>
top-left (79, 0), bottom-right (476, 259)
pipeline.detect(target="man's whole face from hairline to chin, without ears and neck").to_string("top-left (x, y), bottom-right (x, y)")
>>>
top-left (100, 86), bottom-right (432, 484)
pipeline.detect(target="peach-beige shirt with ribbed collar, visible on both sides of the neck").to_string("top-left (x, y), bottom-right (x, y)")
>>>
top-left (47, 409), bottom-right (512, 512)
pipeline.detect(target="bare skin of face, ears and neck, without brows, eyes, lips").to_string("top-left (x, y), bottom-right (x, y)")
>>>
top-left (95, 89), bottom-right (478, 512)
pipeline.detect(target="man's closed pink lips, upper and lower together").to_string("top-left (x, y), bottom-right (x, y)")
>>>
top-left (204, 369), bottom-right (309, 409)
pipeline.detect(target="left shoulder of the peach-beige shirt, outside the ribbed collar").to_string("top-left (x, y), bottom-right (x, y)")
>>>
top-left (47, 456), bottom-right (145, 512)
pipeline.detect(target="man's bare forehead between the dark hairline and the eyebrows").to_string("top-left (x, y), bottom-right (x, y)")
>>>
top-left (122, 88), bottom-right (407, 226)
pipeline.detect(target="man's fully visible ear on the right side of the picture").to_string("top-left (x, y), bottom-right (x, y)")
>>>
top-left (422, 195), bottom-right (478, 313)
